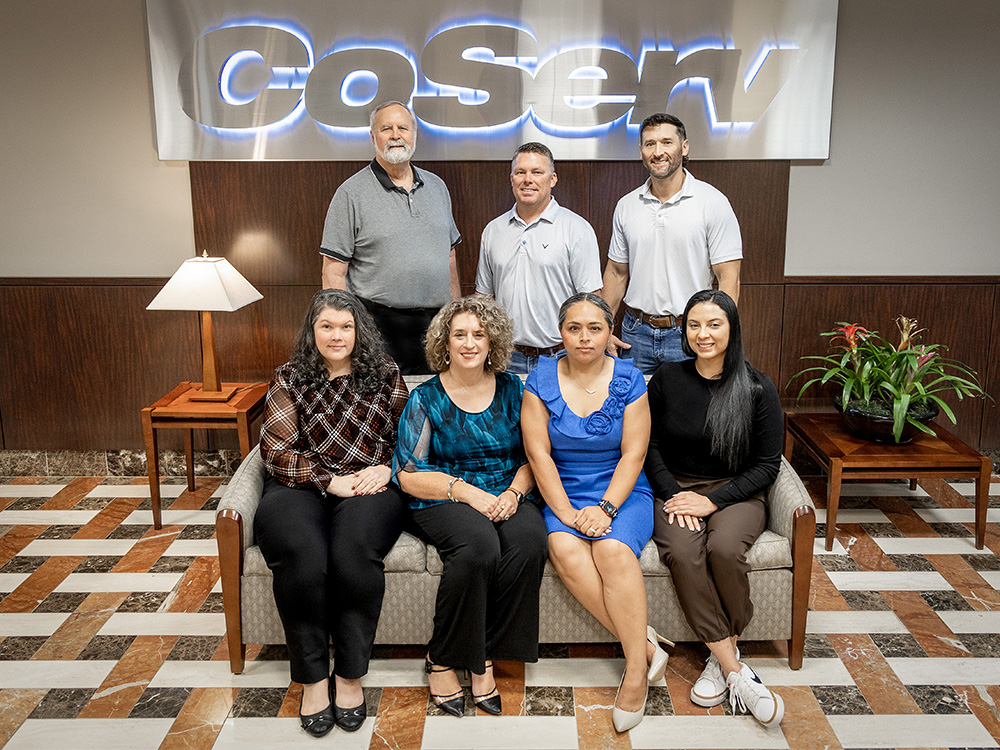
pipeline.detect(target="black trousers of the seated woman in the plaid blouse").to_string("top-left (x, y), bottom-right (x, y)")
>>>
top-left (253, 476), bottom-right (407, 685)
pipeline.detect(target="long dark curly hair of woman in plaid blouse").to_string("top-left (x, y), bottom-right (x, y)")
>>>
top-left (288, 289), bottom-right (393, 393)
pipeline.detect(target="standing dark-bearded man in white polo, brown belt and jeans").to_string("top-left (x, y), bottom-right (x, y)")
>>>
top-left (602, 113), bottom-right (743, 374)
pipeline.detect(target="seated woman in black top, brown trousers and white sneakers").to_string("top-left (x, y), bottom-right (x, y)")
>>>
top-left (645, 289), bottom-right (784, 727)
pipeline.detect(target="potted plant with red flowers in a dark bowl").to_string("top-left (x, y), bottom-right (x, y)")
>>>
top-left (789, 315), bottom-right (989, 443)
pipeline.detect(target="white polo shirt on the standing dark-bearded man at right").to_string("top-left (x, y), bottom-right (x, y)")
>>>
top-left (608, 170), bottom-right (743, 315)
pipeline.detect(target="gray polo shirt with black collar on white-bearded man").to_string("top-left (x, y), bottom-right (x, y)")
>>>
top-left (320, 159), bottom-right (462, 308)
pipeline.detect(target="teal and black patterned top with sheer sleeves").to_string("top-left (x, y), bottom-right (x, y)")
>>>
top-left (392, 372), bottom-right (527, 509)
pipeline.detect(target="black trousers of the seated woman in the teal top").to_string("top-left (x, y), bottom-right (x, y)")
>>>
top-left (413, 503), bottom-right (548, 674)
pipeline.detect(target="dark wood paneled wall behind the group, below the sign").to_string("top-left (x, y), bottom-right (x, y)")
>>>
top-left (0, 160), bottom-right (1000, 450)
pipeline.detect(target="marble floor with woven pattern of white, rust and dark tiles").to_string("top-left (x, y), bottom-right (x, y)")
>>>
top-left (0, 467), bottom-right (1000, 750)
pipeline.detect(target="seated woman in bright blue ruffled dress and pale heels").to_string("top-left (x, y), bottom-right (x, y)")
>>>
top-left (521, 293), bottom-right (667, 732)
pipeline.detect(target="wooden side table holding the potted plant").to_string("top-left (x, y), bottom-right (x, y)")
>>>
top-left (785, 412), bottom-right (993, 552)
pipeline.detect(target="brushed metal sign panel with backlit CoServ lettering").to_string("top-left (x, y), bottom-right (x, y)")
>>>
top-left (147, 0), bottom-right (837, 161)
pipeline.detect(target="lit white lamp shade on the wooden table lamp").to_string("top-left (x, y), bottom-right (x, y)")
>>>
top-left (146, 251), bottom-right (264, 312)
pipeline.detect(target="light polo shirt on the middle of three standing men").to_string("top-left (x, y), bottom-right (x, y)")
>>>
top-left (476, 198), bottom-right (602, 348)
